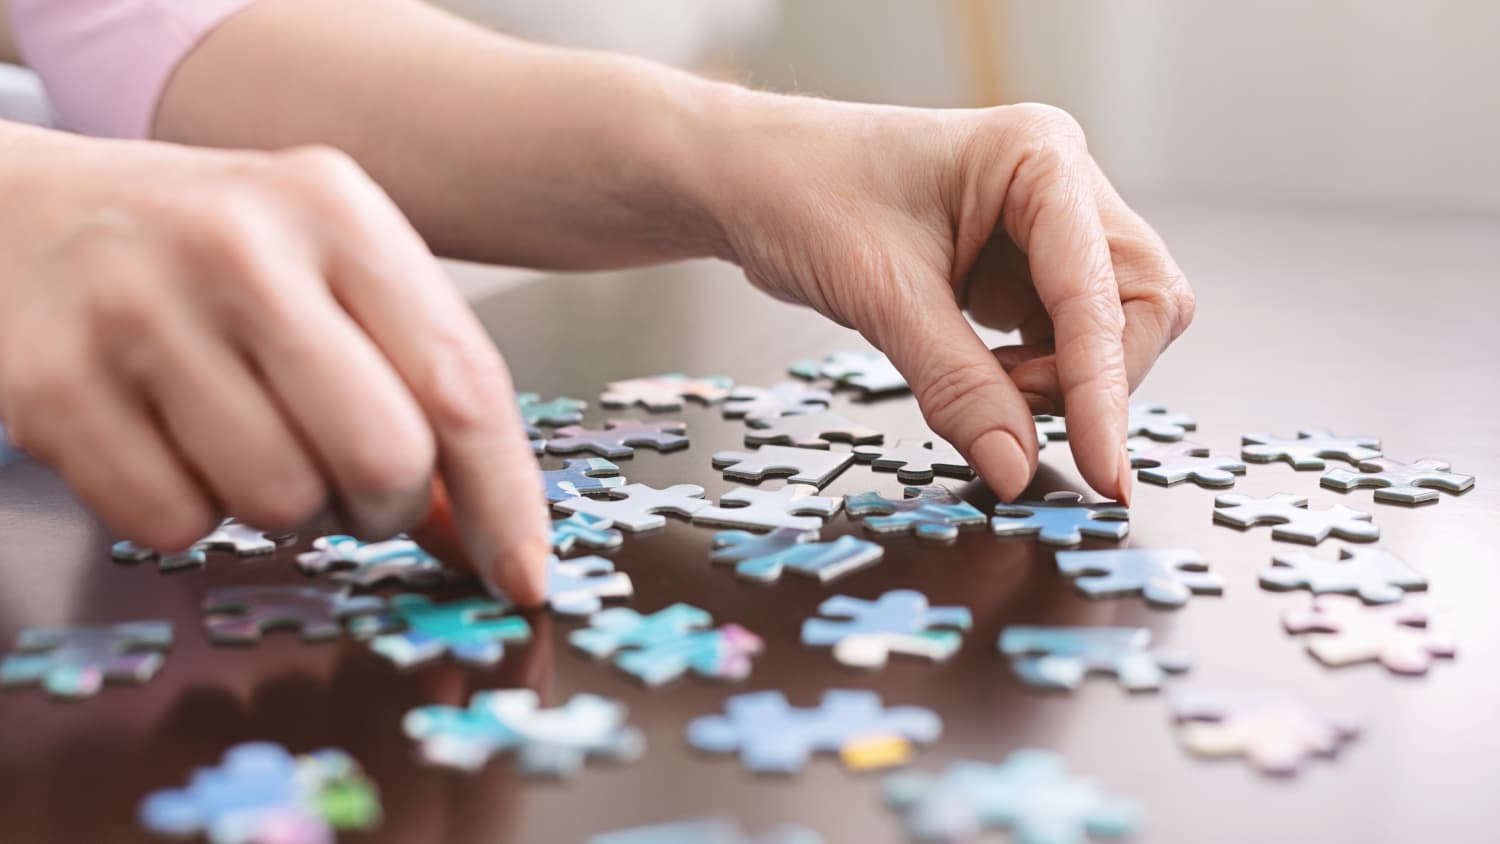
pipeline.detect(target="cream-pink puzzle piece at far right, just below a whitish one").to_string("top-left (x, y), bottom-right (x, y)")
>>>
top-left (1281, 595), bottom-right (1458, 675)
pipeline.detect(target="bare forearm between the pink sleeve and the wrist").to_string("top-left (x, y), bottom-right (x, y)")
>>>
top-left (155, 0), bottom-right (738, 268)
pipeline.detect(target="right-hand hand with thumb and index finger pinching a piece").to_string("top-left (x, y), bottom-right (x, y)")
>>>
top-left (702, 93), bottom-right (1194, 502)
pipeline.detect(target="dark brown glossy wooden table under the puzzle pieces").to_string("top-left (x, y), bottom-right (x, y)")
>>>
top-left (0, 204), bottom-right (1500, 844)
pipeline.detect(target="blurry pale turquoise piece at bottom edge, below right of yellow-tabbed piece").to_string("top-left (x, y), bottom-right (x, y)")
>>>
top-left (885, 748), bottom-right (1140, 844)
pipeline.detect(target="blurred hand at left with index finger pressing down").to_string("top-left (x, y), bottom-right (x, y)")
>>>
top-left (0, 133), bottom-right (551, 604)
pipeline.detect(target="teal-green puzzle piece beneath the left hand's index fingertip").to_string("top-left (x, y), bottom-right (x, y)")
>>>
top-left (350, 594), bottom-right (531, 669)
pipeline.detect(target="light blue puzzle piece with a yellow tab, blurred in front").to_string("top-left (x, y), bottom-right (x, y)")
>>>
top-left (687, 690), bottom-right (942, 774)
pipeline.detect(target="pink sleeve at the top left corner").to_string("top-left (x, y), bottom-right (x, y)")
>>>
top-left (11, 0), bottom-right (255, 138)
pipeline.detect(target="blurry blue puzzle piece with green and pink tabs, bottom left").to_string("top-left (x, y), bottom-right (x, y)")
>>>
top-left (140, 742), bottom-right (381, 844)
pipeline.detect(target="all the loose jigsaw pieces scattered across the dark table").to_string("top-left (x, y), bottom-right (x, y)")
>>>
top-left (0, 352), bottom-right (1475, 844)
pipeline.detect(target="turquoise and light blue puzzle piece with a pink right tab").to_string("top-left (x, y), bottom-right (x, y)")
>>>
top-left (569, 604), bottom-right (765, 687)
